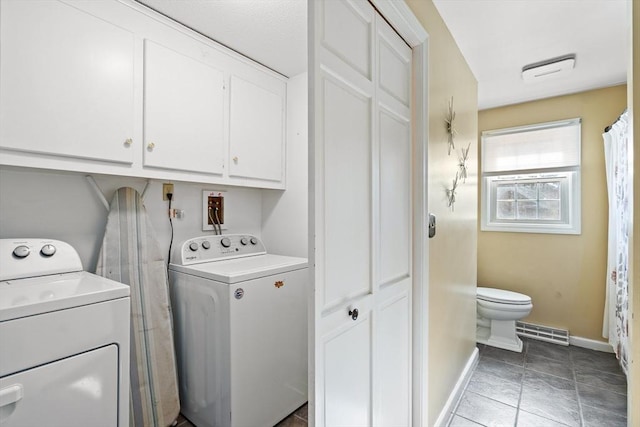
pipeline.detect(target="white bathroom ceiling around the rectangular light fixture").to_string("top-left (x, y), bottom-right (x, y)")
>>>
top-left (434, 0), bottom-right (630, 110)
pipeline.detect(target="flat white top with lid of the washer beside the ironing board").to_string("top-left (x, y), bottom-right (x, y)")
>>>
top-left (170, 254), bottom-right (308, 284)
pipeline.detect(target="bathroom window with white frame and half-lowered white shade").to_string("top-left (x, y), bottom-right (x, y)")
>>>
top-left (481, 119), bottom-right (580, 234)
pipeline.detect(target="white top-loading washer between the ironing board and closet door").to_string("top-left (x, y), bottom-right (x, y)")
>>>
top-left (169, 234), bottom-right (309, 427)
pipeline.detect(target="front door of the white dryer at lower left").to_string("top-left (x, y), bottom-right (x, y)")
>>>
top-left (0, 344), bottom-right (118, 427)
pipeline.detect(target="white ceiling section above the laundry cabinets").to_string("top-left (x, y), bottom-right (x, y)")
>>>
top-left (138, 0), bottom-right (307, 77)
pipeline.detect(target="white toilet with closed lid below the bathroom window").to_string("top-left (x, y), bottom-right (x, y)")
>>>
top-left (476, 287), bottom-right (533, 353)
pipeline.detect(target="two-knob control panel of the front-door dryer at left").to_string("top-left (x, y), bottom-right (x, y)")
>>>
top-left (0, 238), bottom-right (82, 281)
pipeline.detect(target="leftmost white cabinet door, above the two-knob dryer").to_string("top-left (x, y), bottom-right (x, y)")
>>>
top-left (0, 0), bottom-right (134, 163)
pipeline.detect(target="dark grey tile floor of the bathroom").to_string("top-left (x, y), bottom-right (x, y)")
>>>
top-left (450, 340), bottom-right (627, 427)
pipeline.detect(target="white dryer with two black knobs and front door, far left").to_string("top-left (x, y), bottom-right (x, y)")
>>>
top-left (0, 239), bottom-right (129, 427)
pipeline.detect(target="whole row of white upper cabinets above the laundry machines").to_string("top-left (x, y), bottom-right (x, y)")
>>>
top-left (0, 0), bottom-right (287, 189)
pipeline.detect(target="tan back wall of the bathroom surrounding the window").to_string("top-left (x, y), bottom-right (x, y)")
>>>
top-left (478, 85), bottom-right (627, 341)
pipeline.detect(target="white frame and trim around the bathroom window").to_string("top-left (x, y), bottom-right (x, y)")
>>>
top-left (480, 119), bottom-right (582, 235)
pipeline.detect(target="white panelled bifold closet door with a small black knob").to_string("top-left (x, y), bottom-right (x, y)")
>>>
top-left (310, 0), bottom-right (412, 426)
